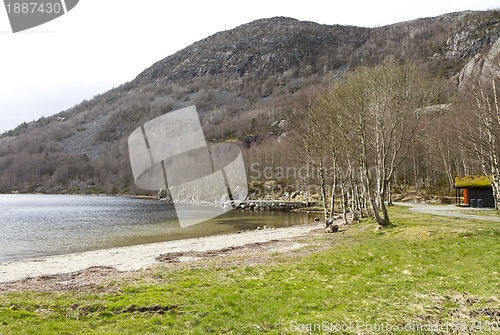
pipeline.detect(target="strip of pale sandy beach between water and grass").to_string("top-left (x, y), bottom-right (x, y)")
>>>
top-left (0, 224), bottom-right (322, 283)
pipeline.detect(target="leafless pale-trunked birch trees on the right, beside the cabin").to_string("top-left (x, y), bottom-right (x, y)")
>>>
top-left (280, 61), bottom-right (500, 226)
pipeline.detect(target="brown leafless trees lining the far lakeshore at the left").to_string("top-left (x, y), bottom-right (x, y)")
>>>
top-left (0, 152), bottom-right (133, 194)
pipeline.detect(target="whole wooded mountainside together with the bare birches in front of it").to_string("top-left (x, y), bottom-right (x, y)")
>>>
top-left (0, 11), bottom-right (500, 210)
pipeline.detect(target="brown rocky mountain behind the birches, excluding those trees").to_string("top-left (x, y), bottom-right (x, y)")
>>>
top-left (0, 11), bottom-right (500, 193)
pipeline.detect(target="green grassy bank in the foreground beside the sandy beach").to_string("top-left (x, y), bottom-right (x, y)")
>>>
top-left (0, 207), bottom-right (500, 335)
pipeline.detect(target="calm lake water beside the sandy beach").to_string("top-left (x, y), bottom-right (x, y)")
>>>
top-left (0, 195), bottom-right (307, 262)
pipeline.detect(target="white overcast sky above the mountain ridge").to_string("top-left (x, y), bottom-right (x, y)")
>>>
top-left (0, 0), bottom-right (500, 133)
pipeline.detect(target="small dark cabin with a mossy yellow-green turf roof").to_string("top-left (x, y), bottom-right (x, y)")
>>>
top-left (453, 176), bottom-right (495, 208)
